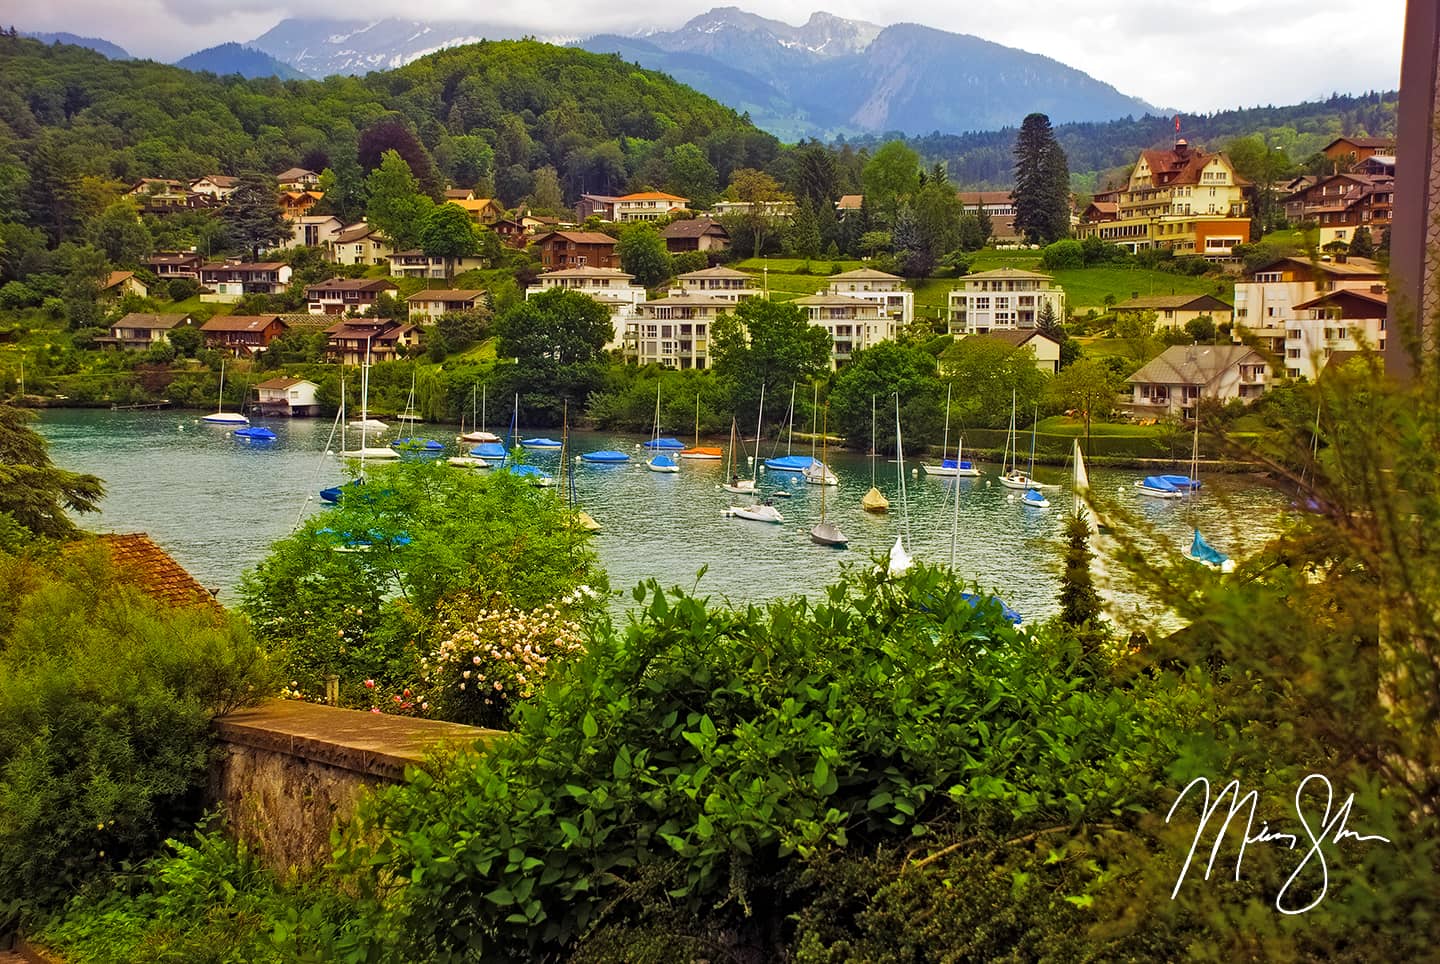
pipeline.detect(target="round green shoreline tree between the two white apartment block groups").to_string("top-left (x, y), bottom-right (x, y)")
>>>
top-left (710, 298), bottom-right (831, 422)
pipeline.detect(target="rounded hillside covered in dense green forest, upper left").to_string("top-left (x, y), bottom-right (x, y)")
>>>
top-left (0, 36), bottom-right (778, 223)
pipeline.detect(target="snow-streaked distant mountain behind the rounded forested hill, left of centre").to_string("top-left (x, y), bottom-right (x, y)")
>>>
top-left (248, 19), bottom-right (544, 76)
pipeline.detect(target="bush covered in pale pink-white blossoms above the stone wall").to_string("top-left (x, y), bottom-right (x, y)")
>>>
top-left (420, 586), bottom-right (593, 726)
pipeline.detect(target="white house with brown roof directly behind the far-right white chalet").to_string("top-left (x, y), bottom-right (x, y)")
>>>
top-left (1234, 255), bottom-right (1385, 357)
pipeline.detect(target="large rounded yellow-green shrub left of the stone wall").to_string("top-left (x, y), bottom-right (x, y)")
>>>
top-left (0, 548), bottom-right (274, 902)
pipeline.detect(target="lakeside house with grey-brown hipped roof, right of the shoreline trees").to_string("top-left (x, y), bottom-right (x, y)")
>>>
top-left (1126, 344), bottom-right (1270, 419)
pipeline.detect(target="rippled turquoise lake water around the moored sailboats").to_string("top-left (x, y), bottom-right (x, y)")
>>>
top-left (37, 411), bottom-right (1284, 620)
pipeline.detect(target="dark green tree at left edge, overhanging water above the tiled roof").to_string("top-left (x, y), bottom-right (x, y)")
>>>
top-left (0, 405), bottom-right (105, 539)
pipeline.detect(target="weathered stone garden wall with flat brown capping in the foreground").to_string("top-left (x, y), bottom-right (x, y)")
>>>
top-left (210, 700), bottom-right (501, 875)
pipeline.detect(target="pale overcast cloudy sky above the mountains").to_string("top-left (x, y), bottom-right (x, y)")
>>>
top-left (11, 0), bottom-right (1405, 111)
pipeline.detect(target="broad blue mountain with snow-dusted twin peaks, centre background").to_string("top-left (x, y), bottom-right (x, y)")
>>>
top-left (580, 7), bottom-right (1153, 137)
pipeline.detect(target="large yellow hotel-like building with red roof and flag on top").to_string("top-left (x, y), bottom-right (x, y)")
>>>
top-left (1076, 138), bottom-right (1250, 261)
